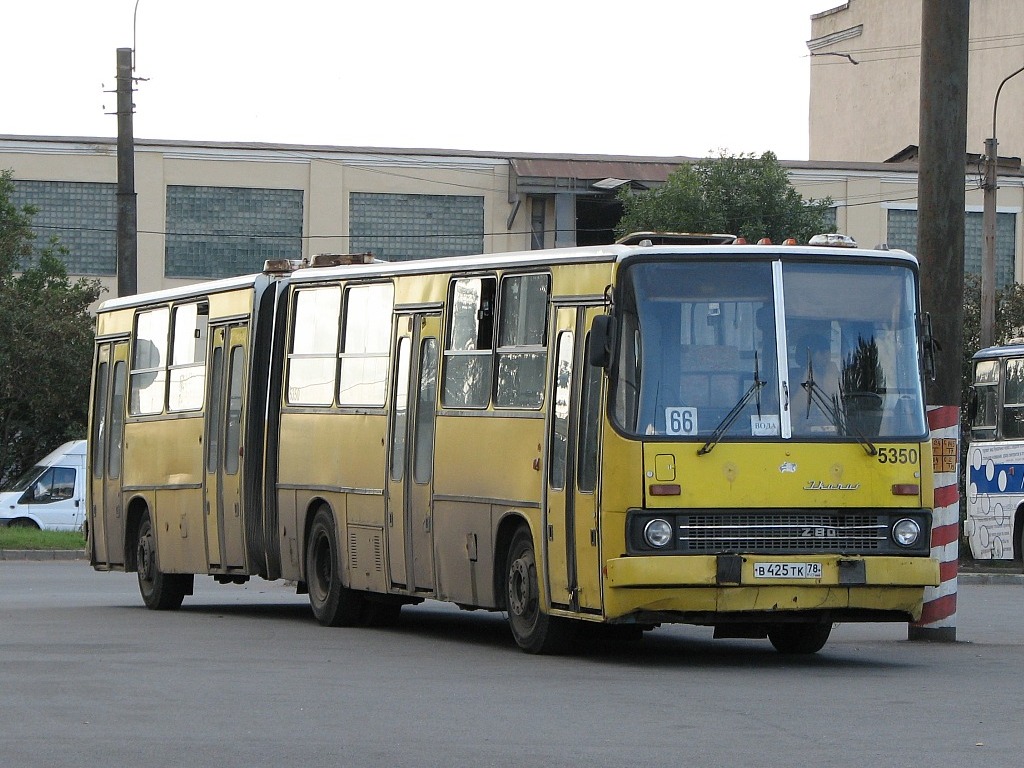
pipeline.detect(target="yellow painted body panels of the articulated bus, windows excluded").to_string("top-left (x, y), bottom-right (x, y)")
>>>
top-left (88, 256), bottom-right (938, 634)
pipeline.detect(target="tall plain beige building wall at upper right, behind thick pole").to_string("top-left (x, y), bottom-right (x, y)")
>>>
top-left (807, 0), bottom-right (1024, 163)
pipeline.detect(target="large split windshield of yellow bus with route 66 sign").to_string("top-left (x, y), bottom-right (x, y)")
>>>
top-left (611, 259), bottom-right (926, 441)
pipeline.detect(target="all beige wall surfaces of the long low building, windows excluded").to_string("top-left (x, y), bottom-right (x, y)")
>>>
top-left (6, 137), bottom-right (1024, 297)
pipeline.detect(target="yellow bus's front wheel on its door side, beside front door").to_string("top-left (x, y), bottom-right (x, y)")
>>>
top-left (505, 527), bottom-right (571, 653)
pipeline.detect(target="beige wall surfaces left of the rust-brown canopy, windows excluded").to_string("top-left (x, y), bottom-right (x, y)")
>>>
top-left (0, 137), bottom-right (529, 297)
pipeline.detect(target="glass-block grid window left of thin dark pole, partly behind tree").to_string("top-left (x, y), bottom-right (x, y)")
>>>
top-left (11, 179), bottom-right (118, 274)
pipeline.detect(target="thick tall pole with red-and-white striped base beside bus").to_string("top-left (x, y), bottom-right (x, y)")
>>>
top-left (907, 0), bottom-right (971, 642)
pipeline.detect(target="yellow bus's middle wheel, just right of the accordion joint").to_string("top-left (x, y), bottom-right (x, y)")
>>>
top-left (306, 507), bottom-right (366, 627)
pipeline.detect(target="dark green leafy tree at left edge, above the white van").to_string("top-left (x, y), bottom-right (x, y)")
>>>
top-left (0, 171), bottom-right (100, 482)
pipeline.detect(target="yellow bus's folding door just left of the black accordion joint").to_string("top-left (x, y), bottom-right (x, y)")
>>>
top-left (205, 325), bottom-right (249, 568)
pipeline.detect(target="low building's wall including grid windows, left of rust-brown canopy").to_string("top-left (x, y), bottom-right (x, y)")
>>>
top-left (0, 137), bottom-right (520, 296)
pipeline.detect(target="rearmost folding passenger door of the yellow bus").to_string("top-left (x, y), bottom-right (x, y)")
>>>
top-left (89, 341), bottom-right (128, 565)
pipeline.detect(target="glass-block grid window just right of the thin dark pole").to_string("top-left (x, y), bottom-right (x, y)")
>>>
top-left (164, 185), bottom-right (302, 278)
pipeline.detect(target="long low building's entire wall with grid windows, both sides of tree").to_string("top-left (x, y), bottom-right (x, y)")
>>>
top-left (0, 137), bottom-right (1024, 297)
